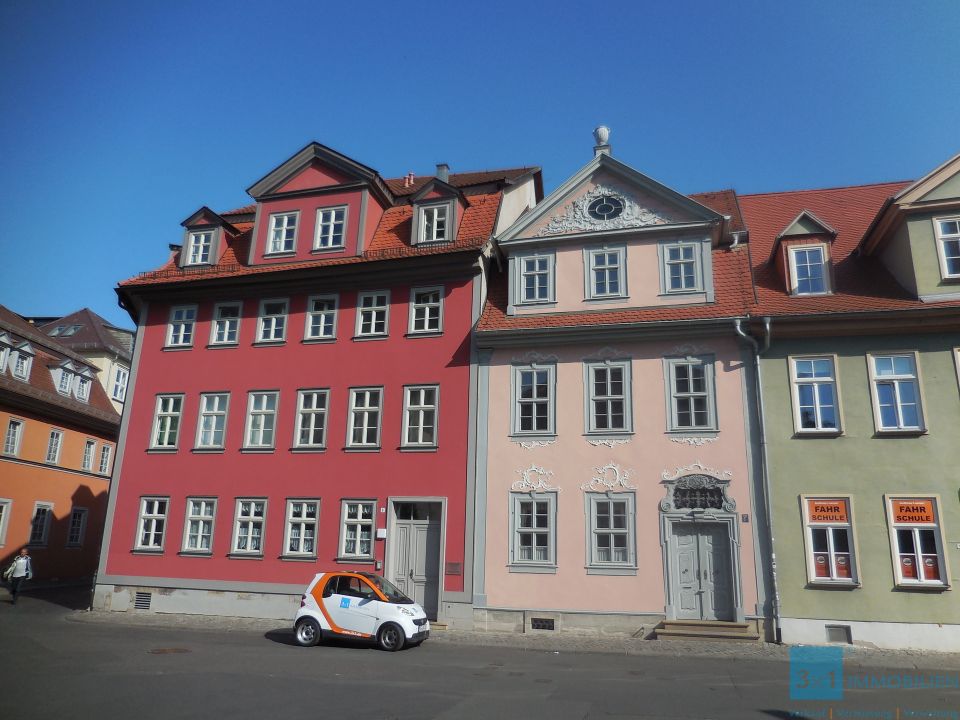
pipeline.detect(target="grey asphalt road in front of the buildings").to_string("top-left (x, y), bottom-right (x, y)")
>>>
top-left (0, 596), bottom-right (960, 720)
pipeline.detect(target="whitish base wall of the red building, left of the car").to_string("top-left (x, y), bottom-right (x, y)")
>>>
top-left (93, 585), bottom-right (300, 623)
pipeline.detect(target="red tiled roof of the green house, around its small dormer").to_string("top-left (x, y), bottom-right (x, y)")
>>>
top-left (739, 182), bottom-right (960, 315)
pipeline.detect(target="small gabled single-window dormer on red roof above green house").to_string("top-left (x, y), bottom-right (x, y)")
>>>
top-left (770, 210), bottom-right (837, 297)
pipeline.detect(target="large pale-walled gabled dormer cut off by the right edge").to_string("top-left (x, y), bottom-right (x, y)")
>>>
top-left (859, 154), bottom-right (960, 303)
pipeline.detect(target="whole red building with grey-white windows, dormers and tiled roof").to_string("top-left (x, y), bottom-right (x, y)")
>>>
top-left (95, 143), bottom-right (542, 620)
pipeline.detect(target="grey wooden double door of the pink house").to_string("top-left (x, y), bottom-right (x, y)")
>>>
top-left (673, 523), bottom-right (733, 620)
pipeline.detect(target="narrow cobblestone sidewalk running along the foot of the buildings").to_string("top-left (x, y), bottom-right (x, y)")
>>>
top-left (67, 610), bottom-right (960, 671)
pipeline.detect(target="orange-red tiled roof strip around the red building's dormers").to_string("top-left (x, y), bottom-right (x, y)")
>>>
top-left (120, 197), bottom-right (501, 287)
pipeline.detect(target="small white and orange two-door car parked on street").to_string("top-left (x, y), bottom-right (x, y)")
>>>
top-left (293, 572), bottom-right (430, 651)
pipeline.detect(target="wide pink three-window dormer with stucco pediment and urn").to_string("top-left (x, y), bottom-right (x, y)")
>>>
top-left (497, 129), bottom-right (730, 315)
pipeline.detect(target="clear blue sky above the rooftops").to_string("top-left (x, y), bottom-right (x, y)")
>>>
top-left (0, 0), bottom-right (960, 326)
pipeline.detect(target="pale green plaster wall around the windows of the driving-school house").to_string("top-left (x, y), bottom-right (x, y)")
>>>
top-left (761, 334), bottom-right (960, 623)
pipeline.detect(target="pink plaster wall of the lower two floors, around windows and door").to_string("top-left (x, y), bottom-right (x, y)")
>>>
top-left (485, 337), bottom-right (757, 613)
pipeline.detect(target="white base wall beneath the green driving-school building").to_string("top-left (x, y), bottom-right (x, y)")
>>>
top-left (780, 618), bottom-right (960, 652)
